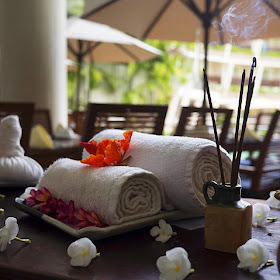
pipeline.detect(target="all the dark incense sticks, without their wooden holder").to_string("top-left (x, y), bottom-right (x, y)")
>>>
top-left (204, 57), bottom-right (257, 187)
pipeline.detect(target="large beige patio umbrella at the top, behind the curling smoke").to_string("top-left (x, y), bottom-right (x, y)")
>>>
top-left (83, 0), bottom-right (280, 106)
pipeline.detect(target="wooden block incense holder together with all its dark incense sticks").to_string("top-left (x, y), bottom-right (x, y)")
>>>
top-left (203, 57), bottom-right (257, 253)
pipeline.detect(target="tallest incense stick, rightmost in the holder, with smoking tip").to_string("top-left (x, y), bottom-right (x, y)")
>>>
top-left (232, 57), bottom-right (257, 186)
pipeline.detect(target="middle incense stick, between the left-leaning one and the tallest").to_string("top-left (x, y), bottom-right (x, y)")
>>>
top-left (230, 70), bottom-right (245, 187)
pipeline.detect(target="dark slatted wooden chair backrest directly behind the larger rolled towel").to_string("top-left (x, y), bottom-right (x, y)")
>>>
top-left (82, 103), bottom-right (167, 142)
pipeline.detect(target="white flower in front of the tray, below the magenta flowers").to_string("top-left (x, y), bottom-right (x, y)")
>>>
top-left (67, 237), bottom-right (97, 266)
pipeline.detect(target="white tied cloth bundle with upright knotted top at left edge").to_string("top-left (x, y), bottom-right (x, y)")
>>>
top-left (0, 115), bottom-right (43, 187)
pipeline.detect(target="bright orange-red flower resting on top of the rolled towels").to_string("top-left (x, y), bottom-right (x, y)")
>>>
top-left (81, 130), bottom-right (133, 167)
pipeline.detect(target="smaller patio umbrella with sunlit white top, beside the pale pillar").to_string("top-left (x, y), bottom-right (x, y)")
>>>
top-left (66, 18), bottom-right (162, 109)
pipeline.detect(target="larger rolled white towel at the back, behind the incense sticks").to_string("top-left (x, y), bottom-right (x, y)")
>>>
top-left (83, 129), bottom-right (231, 216)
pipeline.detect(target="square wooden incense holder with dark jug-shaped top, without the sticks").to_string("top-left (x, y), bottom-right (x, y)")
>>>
top-left (203, 181), bottom-right (252, 253)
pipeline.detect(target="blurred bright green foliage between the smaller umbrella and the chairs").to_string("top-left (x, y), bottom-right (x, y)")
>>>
top-left (68, 41), bottom-right (192, 108)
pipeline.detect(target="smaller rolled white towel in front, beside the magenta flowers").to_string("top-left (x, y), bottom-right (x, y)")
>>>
top-left (37, 158), bottom-right (164, 225)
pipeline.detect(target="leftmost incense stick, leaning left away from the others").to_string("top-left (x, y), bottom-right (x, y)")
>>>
top-left (203, 69), bottom-right (225, 185)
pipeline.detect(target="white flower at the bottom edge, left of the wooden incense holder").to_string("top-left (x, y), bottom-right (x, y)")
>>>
top-left (157, 247), bottom-right (193, 280)
